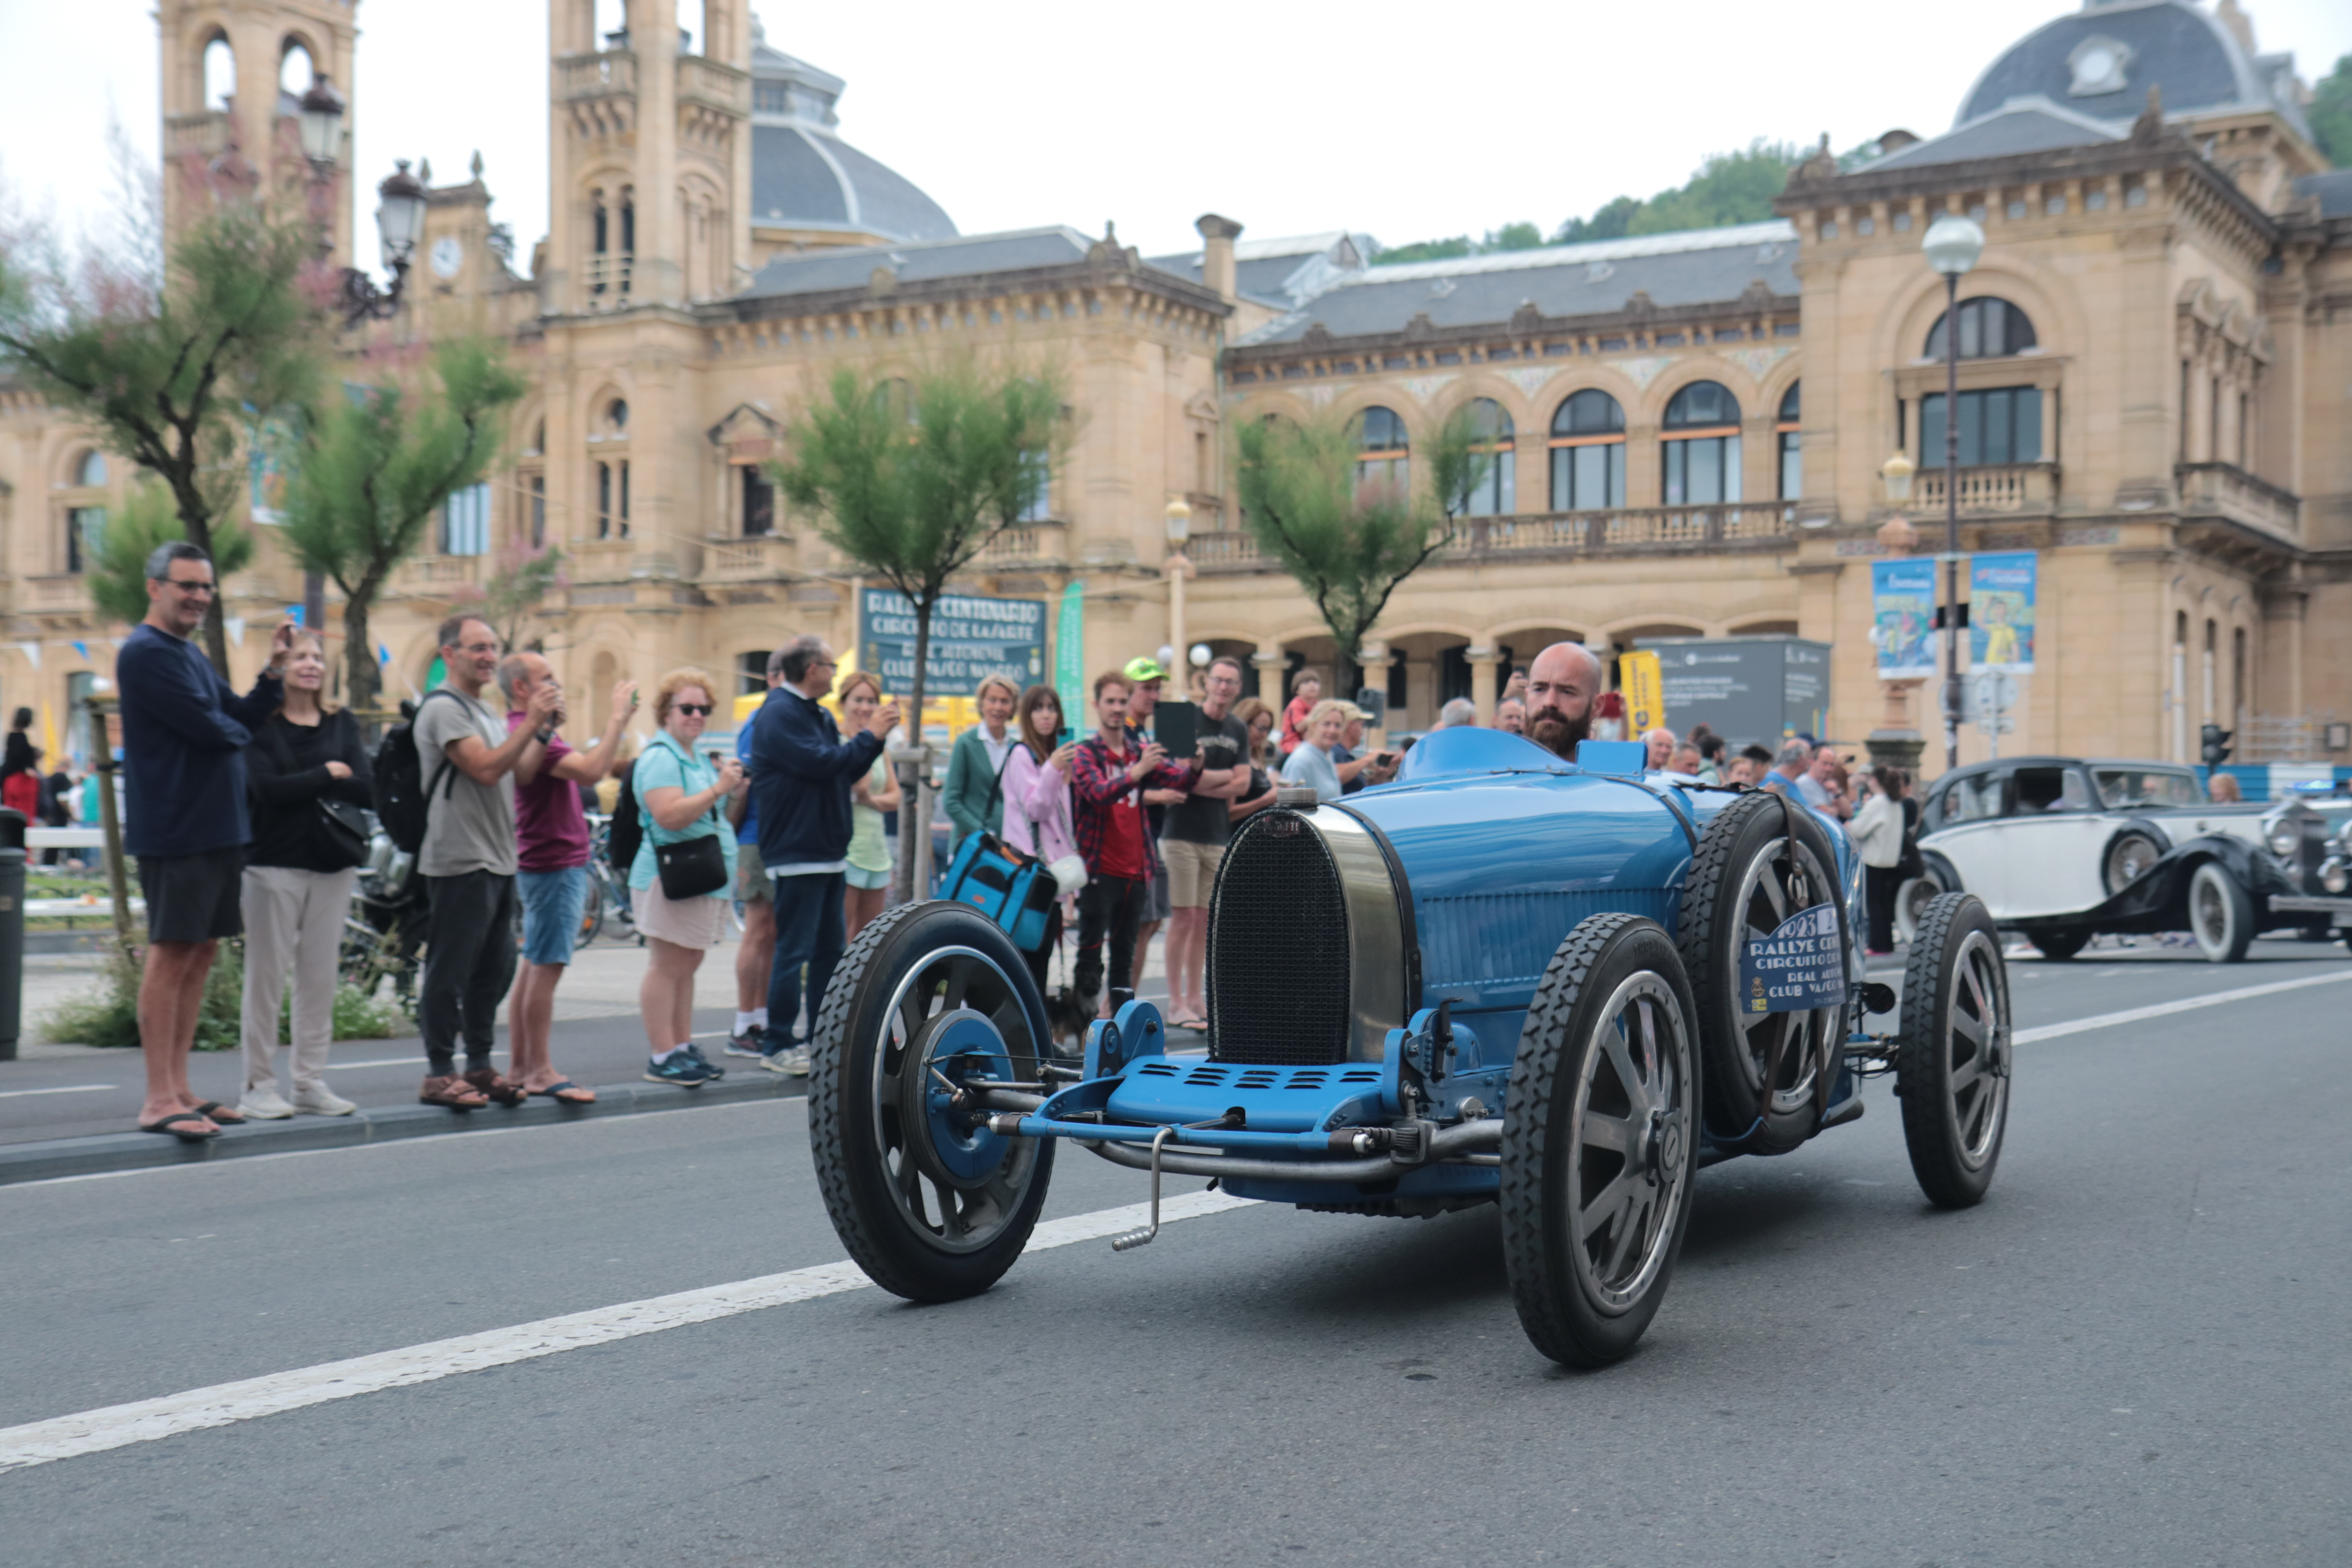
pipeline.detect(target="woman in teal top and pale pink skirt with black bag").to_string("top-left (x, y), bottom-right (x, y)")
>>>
top-left (628, 670), bottom-right (743, 1089)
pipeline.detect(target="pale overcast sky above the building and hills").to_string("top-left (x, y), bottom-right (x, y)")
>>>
top-left (0, 0), bottom-right (2352, 271)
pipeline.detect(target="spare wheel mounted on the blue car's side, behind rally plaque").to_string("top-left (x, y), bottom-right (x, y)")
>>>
top-left (1677, 795), bottom-right (1853, 1154)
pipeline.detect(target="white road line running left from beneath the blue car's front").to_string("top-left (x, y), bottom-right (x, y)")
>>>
top-left (0, 1192), bottom-right (1254, 1472)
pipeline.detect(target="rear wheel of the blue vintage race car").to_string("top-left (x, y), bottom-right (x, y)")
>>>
top-left (1896, 893), bottom-right (2009, 1208)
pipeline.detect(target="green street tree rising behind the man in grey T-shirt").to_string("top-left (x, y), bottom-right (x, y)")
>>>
top-left (282, 339), bottom-right (527, 708)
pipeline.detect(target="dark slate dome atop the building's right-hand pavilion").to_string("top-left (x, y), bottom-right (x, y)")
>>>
top-left (1955, 0), bottom-right (2310, 139)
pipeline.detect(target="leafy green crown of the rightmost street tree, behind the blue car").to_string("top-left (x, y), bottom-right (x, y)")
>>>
top-left (1237, 409), bottom-right (1496, 691)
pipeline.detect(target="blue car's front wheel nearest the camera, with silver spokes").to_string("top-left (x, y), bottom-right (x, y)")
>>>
top-left (1501, 915), bottom-right (1700, 1366)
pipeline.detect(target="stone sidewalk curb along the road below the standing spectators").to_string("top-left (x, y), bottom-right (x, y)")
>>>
top-left (0, 1063), bottom-right (809, 1185)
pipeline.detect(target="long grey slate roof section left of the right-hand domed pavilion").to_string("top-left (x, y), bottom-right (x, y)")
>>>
top-left (1242, 219), bottom-right (1799, 343)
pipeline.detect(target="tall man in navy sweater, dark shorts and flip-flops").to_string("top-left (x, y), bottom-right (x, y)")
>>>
top-left (115, 541), bottom-right (294, 1143)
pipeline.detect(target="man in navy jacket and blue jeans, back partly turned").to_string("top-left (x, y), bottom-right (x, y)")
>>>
top-left (746, 637), bottom-right (898, 1074)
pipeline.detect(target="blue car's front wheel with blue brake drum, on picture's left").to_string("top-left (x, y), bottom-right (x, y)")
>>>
top-left (809, 903), bottom-right (1054, 1302)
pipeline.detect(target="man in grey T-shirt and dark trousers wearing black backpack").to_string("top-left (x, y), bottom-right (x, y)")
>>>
top-left (412, 616), bottom-right (562, 1110)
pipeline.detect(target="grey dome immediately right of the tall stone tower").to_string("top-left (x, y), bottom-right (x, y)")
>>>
top-left (750, 21), bottom-right (955, 240)
